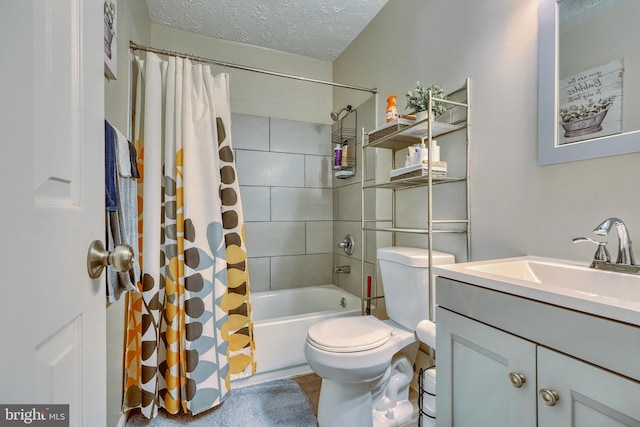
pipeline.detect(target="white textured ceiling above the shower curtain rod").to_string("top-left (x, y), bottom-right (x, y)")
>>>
top-left (147, 0), bottom-right (387, 61)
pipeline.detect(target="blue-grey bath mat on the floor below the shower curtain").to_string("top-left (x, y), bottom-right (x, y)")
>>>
top-left (126, 380), bottom-right (318, 427)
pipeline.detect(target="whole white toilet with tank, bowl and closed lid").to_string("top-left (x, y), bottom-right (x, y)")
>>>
top-left (304, 247), bottom-right (455, 427)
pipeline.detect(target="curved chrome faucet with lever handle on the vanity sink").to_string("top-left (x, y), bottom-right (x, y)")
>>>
top-left (573, 218), bottom-right (640, 274)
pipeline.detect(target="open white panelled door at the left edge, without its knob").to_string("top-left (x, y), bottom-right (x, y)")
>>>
top-left (0, 0), bottom-right (106, 426)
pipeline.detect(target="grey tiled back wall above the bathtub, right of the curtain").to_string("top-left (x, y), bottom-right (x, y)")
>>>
top-left (231, 113), bottom-right (334, 292)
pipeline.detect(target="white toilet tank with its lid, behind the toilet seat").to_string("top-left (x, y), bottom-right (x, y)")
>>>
top-left (378, 246), bottom-right (455, 330)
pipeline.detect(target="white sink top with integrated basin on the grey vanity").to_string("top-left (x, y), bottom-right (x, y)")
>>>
top-left (433, 256), bottom-right (640, 326)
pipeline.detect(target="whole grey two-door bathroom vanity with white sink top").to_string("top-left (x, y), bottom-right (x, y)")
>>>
top-left (433, 257), bottom-right (640, 427)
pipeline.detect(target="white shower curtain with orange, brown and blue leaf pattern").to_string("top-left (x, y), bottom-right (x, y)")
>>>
top-left (123, 53), bottom-right (255, 418)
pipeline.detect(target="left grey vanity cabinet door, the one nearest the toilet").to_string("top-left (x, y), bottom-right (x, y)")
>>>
top-left (436, 307), bottom-right (537, 427)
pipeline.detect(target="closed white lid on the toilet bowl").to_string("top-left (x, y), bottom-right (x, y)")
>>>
top-left (307, 316), bottom-right (393, 353)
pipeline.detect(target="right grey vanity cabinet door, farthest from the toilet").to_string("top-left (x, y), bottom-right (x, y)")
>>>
top-left (538, 347), bottom-right (640, 427)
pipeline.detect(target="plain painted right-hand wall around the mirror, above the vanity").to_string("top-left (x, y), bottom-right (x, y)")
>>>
top-left (334, 0), bottom-right (640, 262)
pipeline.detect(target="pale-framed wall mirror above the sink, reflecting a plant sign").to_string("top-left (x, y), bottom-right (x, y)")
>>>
top-left (538, 0), bottom-right (640, 165)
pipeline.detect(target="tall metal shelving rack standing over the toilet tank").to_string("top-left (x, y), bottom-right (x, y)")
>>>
top-left (361, 79), bottom-right (471, 425)
